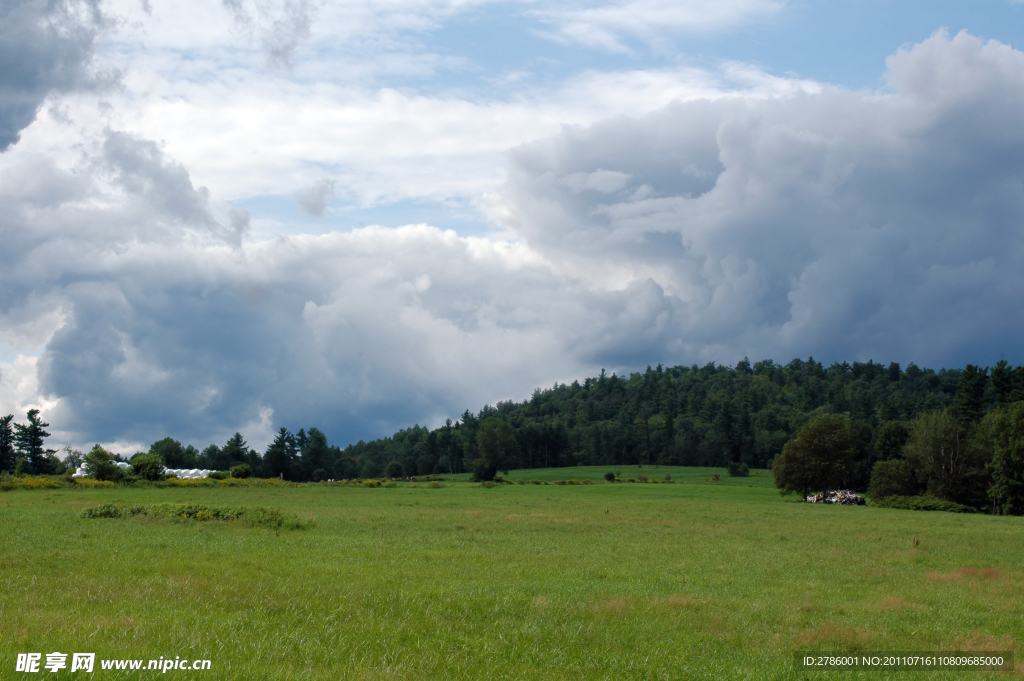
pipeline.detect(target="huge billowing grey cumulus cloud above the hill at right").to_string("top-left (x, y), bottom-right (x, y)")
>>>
top-left (494, 33), bottom-right (1024, 364)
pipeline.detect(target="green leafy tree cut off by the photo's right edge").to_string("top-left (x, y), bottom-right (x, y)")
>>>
top-left (985, 401), bottom-right (1024, 515)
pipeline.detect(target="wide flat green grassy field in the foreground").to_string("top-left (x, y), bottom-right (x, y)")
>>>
top-left (0, 467), bottom-right (1024, 680)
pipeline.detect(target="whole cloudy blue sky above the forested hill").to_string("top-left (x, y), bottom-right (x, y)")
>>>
top-left (0, 0), bottom-right (1024, 453)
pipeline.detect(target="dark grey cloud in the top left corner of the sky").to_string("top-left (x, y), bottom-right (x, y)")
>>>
top-left (0, 0), bottom-right (103, 153)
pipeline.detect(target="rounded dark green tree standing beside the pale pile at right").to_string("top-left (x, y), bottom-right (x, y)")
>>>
top-left (772, 414), bottom-right (857, 499)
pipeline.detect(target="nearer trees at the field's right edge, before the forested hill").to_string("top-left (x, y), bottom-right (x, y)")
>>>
top-left (772, 361), bottom-right (1024, 515)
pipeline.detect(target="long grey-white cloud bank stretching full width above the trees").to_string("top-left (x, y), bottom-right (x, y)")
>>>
top-left (0, 34), bottom-right (1024, 450)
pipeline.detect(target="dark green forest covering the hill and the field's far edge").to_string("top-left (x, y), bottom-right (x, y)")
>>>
top-left (0, 358), bottom-right (1024, 497)
